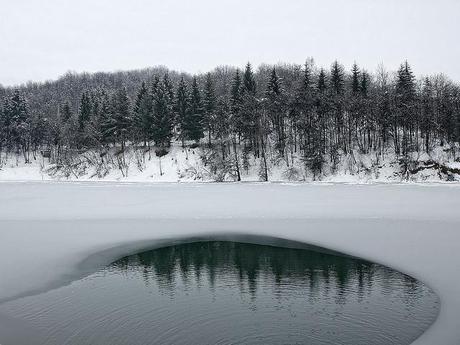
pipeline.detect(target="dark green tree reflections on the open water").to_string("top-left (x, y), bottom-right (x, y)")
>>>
top-left (113, 241), bottom-right (424, 304)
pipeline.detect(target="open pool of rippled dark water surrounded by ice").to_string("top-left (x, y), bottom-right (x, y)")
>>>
top-left (0, 241), bottom-right (439, 345)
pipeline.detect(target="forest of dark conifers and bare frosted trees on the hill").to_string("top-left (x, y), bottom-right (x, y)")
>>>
top-left (0, 60), bottom-right (460, 180)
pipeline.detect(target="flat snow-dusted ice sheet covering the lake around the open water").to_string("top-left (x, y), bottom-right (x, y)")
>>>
top-left (0, 182), bottom-right (460, 345)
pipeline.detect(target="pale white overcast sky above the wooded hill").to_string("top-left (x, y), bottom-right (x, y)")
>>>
top-left (0, 0), bottom-right (460, 85)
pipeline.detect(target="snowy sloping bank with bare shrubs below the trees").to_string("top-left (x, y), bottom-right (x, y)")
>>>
top-left (0, 143), bottom-right (460, 183)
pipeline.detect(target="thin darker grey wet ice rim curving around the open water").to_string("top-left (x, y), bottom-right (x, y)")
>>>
top-left (0, 232), bottom-right (441, 345)
